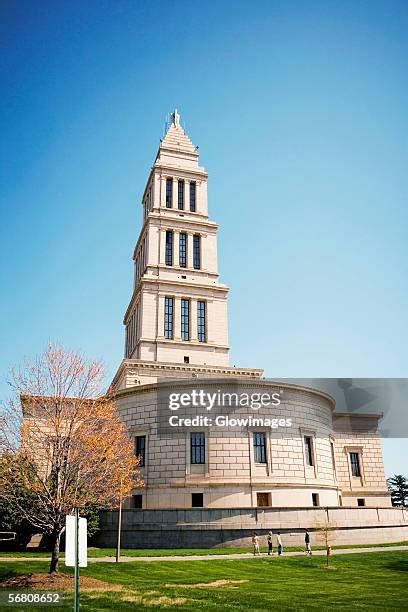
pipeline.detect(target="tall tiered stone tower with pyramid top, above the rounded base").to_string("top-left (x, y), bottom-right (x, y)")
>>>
top-left (111, 110), bottom-right (262, 386)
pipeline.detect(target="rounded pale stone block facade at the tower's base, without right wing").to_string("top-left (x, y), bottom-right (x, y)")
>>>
top-left (113, 379), bottom-right (378, 509)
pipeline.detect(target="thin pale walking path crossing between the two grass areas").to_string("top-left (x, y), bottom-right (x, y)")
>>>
top-left (0, 546), bottom-right (408, 563)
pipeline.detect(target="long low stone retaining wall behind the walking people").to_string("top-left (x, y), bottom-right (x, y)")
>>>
top-left (93, 507), bottom-right (408, 548)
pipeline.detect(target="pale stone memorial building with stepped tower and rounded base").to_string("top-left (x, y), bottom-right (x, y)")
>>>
top-left (111, 111), bottom-right (391, 510)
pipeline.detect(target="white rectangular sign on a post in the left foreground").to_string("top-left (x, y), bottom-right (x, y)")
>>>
top-left (65, 508), bottom-right (88, 612)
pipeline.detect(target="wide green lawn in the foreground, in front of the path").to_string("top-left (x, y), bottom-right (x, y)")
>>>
top-left (0, 552), bottom-right (408, 612)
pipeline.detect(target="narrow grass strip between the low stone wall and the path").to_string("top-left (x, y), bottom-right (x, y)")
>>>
top-left (0, 541), bottom-right (408, 559)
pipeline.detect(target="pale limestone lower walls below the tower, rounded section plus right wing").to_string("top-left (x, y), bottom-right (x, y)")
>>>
top-left (117, 379), bottom-right (390, 509)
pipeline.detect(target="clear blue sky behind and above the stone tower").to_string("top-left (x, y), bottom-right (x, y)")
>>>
top-left (0, 0), bottom-right (408, 473)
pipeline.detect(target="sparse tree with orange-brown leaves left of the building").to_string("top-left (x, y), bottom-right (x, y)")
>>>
top-left (0, 345), bottom-right (143, 572)
